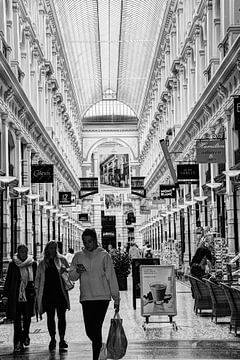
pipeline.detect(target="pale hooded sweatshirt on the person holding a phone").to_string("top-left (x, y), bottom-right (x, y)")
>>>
top-left (69, 247), bottom-right (120, 304)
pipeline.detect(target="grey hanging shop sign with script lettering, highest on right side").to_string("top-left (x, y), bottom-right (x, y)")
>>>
top-left (196, 139), bottom-right (226, 164)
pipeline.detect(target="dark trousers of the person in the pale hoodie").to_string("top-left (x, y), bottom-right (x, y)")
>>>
top-left (82, 300), bottom-right (109, 360)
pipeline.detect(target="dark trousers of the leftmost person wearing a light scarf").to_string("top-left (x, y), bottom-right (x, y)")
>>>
top-left (13, 302), bottom-right (32, 345)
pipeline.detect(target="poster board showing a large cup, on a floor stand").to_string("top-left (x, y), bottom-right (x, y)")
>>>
top-left (140, 265), bottom-right (177, 316)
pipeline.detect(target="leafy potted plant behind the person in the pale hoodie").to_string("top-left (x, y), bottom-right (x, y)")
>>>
top-left (112, 251), bottom-right (131, 290)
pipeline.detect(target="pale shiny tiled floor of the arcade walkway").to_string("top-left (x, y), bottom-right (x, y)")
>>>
top-left (0, 277), bottom-right (240, 360)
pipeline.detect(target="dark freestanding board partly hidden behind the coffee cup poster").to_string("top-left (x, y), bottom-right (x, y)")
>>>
top-left (132, 258), bottom-right (160, 310)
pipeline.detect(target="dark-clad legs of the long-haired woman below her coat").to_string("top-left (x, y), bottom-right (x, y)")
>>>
top-left (46, 303), bottom-right (66, 340)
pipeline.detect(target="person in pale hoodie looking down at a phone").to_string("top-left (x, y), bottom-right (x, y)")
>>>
top-left (69, 228), bottom-right (120, 360)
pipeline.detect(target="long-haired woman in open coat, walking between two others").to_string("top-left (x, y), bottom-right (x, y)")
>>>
top-left (35, 240), bottom-right (70, 351)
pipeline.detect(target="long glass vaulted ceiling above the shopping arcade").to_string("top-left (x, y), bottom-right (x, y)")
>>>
top-left (51, 0), bottom-right (167, 121)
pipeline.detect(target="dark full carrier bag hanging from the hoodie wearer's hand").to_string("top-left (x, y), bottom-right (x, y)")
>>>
top-left (107, 313), bottom-right (128, 359)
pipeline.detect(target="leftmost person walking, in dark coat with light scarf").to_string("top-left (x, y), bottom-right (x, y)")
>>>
top-left (2, 244), bottom-right (37, 353)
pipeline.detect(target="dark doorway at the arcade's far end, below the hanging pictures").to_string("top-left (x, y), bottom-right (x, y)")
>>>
top-left (101, 211), bottom-right (117, 250)
